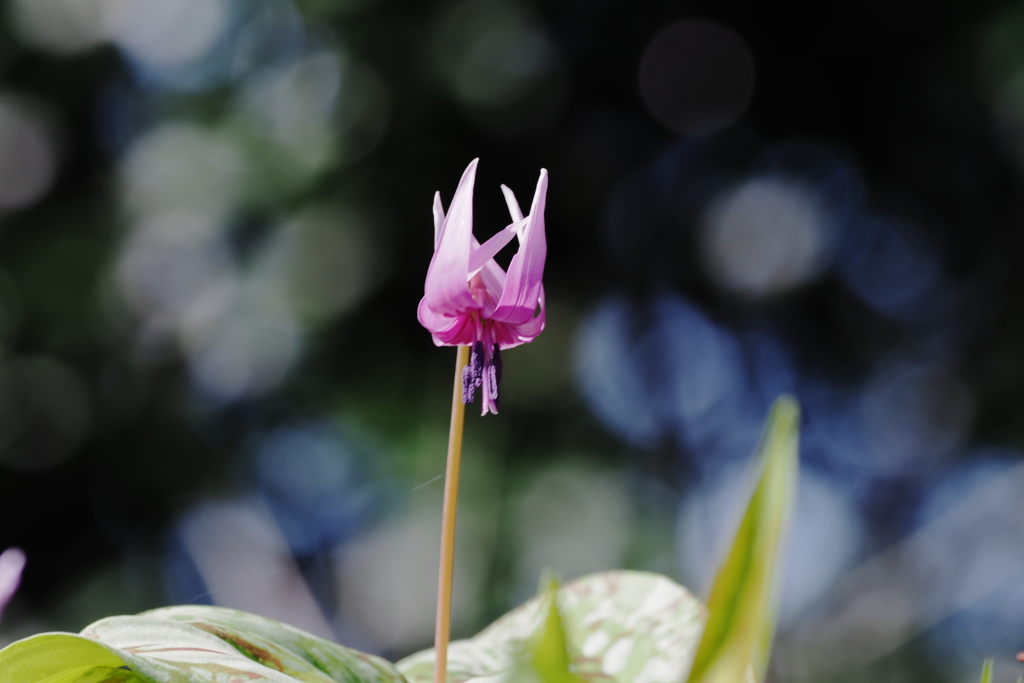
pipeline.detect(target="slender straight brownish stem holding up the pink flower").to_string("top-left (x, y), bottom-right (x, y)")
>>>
top-left (434, 346), bottom-right (469, 683)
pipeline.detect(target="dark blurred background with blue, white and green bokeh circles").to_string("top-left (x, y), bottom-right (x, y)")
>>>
top-left (0, 0), bottom-right (1024, 682)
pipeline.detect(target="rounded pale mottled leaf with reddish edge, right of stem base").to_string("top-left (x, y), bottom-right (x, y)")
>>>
top-left (396, 571), bottom-right (707, 683)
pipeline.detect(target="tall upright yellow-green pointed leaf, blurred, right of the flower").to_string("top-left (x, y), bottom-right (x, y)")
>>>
top-left (688, 396), bottom-right (800, 683)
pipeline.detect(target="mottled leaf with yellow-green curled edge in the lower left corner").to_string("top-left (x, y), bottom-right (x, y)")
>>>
top-left (0, 606), bottom-right (404, 683)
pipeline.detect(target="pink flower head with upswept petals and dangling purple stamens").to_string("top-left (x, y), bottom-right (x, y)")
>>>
top-left (418, 159), bottom-right (548, 415)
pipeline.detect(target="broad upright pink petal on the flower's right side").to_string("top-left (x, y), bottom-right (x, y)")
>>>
top-left (489, 169), bottom-right (548, 325)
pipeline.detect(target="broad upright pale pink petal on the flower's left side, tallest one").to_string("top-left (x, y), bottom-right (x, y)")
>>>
top-left (424, 159), bottom-right (479, 315)
